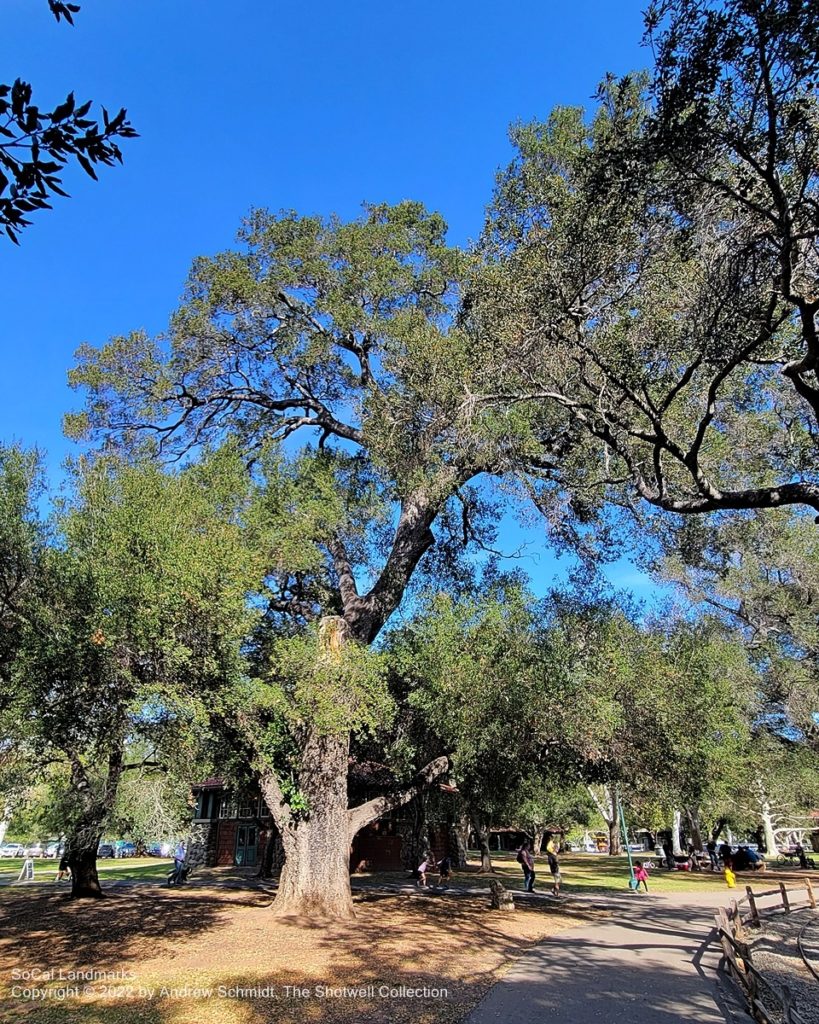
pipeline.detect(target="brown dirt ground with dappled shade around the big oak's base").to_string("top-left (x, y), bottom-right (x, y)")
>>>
top-left (0, 888), bottom-right (601, 1024)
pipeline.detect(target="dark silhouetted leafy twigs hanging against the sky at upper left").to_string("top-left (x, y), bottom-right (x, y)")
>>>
top-left (0, 0), bottom-right (136, 244)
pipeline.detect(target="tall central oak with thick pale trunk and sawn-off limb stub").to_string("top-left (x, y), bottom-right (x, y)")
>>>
top-left (69, 197), bottom-right (577, 915)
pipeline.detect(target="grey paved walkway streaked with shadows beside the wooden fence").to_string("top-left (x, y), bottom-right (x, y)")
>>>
top-left (465, 890), bottom-right (749, 1024)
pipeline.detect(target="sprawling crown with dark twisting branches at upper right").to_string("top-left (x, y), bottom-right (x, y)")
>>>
top-left (469, 0), bottom-right (819, 514)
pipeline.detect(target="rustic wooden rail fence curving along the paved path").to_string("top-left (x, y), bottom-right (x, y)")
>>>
top-left (715, 879), bottom-right (816, 1024)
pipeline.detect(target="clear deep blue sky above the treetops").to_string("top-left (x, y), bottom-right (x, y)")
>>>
top-left (0, 0), bottom-right (663, 593)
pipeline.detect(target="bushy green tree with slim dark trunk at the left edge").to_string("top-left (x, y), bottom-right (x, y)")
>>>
top-left (0, 449), bottom-right (253, 897)
